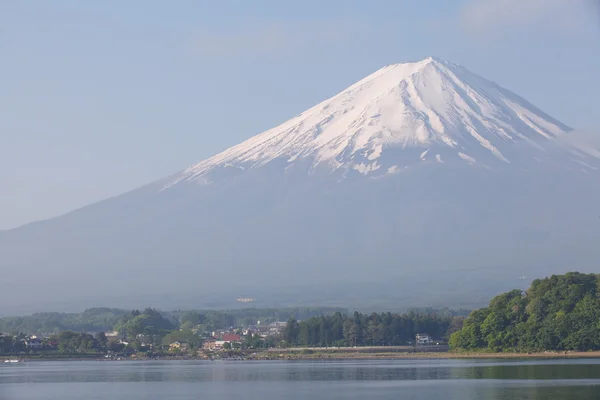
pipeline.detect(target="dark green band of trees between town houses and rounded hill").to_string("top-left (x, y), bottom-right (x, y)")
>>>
top-left (283, 312), bottom-right (463, 347)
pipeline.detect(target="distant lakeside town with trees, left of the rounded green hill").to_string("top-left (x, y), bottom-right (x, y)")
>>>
top-left (0, 308), bottom-right (452, 360)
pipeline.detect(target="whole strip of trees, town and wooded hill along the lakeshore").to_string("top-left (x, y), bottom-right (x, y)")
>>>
top-left (0, 272), bottom-right (600, 358)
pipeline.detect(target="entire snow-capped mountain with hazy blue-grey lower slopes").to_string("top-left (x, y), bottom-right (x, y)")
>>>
top-left (0, 58), bottom-right (600, 312)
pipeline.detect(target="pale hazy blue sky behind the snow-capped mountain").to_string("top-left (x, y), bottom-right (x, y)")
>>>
top-left (0, 0), bottom-right (600, 229)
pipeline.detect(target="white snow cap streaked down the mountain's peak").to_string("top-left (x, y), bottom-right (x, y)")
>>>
top-left (166, 57), bottom-right (571, 184)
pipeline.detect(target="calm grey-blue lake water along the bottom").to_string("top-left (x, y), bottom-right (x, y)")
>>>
top-left (0, 360), bottom-right (600, 400)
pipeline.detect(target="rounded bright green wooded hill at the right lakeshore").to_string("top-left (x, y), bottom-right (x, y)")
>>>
top-left (450, 272), bottom-right (600, 352)
